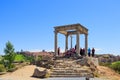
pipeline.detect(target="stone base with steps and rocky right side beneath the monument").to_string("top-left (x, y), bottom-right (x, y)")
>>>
top-left (50, 57), bottom-right (98, 78)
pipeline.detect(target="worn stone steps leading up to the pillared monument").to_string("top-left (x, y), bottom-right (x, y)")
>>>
top-left (51, 59), bottom-right (93, 77)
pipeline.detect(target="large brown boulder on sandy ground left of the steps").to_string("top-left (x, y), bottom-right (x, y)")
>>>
top-left (33, 68), bottom-right (49, 78)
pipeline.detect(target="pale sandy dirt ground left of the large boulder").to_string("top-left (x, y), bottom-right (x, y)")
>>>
top-left (0, 65), bottom-right (44, 80)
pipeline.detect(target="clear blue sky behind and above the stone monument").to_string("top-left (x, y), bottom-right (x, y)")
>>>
top-left (0, 0), bottom-right (120, 55)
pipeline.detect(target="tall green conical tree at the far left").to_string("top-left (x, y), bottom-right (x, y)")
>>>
top-left (4, 41), bottom-right (15, 69)
